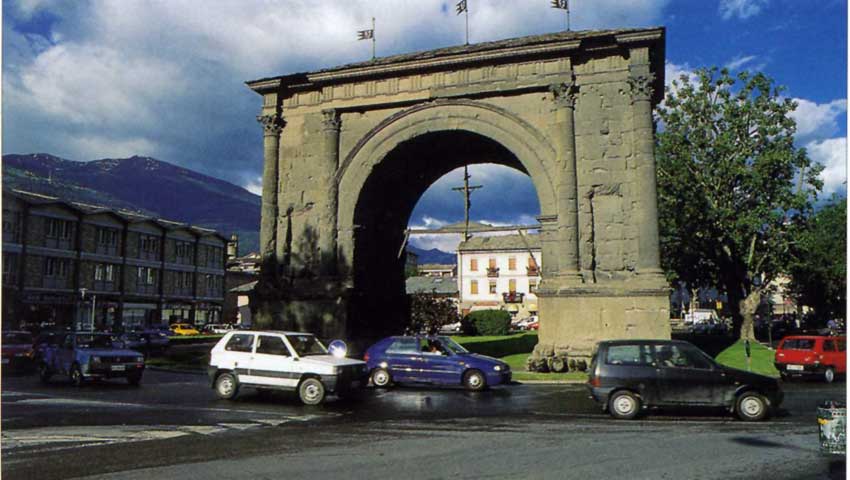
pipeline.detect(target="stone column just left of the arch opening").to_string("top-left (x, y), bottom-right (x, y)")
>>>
top-left (319, 109), bottom-right (341, 276)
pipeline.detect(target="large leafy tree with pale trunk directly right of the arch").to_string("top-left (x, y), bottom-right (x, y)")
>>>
top-left (656, 68), bottom-right (821, 338)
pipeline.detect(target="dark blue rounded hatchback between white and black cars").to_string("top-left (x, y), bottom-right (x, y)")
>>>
top-left (363, 335), bottom-right (511, 391)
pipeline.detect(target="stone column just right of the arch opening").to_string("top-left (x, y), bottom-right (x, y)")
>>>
top-left (550, 80), bottom-right (581, 283)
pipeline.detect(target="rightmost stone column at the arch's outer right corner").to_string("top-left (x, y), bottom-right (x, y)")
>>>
top-left (629, 68), bottom-right (662, 274)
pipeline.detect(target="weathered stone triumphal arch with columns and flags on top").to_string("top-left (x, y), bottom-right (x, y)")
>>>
top-left (248, 28), bottom-right (670, 356)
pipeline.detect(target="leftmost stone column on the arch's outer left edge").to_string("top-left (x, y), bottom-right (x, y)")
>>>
top-left (257, 115), bottom-right (286, 274)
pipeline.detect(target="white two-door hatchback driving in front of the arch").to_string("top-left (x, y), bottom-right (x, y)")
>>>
top-left (208, 331), bottom-right (369, 405)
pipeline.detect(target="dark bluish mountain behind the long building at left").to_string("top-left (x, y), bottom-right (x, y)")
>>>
top-left (3, 153), bottom-right (260, 253)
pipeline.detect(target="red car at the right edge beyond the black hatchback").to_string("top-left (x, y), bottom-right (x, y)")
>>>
top-left (774, 335), bottom-right (847, 383)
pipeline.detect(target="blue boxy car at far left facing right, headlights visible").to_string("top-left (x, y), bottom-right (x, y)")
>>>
top-left (39, 333), bottom-right (145, 386)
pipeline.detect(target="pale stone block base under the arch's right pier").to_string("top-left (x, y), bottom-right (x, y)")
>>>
top-left (529, 285), bottom-right (670, 364)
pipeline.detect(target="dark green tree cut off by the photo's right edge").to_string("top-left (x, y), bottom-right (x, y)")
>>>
top-left (790, 196), bottom-right (847, 324)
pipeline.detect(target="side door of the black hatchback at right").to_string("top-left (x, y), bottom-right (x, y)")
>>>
top-left (655, 343), bottom-right (727, 405)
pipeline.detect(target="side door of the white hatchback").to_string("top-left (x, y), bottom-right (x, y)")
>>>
top-left (242, 334), bottom-right (301, 388)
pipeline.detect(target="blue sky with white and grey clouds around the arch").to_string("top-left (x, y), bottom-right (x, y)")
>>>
top-left (2, 0), bottom-right (847, 255)
